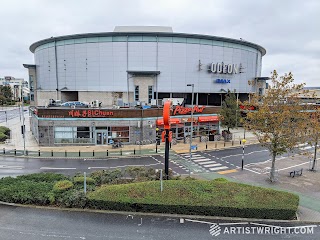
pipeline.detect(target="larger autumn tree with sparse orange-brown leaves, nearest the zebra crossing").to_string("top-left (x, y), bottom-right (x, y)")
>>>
top-left (244, 70), bottom-right (306, 182)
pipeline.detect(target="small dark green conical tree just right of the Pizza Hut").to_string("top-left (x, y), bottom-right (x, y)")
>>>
top-left (220, 90), bottom-right (241, 132)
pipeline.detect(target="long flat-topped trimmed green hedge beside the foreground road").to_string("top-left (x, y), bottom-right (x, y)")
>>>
top-left (87, 180), bottom-right (299, 219)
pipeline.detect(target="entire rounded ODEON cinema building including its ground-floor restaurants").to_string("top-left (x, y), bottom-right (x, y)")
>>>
top-left (24, 27), bottom-right (266, 146)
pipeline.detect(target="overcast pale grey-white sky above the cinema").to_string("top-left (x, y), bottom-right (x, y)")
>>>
top-left (0, 0), bottom-right (320, 87)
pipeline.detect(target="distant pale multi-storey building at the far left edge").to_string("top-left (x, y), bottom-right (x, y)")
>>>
top-left (0, 76), bottom-right (30, 101)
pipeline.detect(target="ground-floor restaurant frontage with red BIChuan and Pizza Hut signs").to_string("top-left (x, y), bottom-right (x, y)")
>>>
top-left (30, 106), bottom-right (219, 146)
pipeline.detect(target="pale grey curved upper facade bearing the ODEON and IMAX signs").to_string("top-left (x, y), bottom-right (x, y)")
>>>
top-left (25, 27), bottom-right (266, 106)
